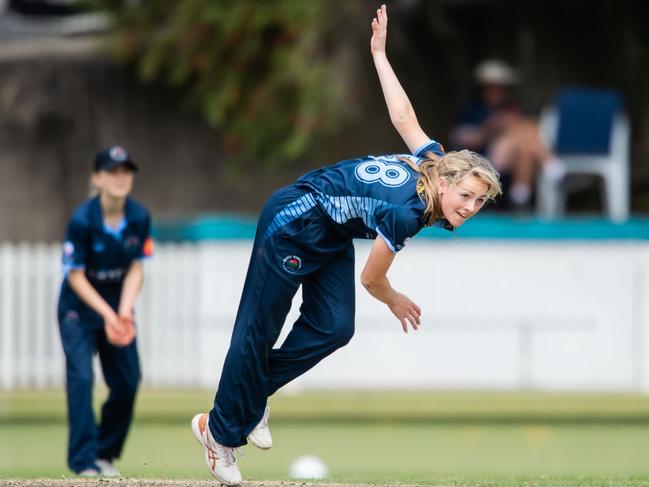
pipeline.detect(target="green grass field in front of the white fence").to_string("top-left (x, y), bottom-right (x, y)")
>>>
top-left (0, 390), bottom-right (649, 486)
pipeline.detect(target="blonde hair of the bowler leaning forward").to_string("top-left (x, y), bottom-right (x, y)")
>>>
top-left (402, 150), bottom-right (502, 225)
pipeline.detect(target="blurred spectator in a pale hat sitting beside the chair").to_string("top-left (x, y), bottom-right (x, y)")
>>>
top-left (451, 60), bottom-right (561, 209)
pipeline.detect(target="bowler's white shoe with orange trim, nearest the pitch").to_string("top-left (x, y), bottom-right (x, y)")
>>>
top-left (192, 414), bottom-right (241, 485)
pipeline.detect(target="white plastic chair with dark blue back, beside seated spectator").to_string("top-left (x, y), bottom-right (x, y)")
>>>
top-left (537, 89), bottom-right (630, 222)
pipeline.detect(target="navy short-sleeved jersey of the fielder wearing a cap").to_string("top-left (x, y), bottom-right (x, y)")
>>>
top-left (59, 197), bottom-right (153, 321)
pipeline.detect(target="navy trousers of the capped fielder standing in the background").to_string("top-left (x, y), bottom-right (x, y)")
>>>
top-left (59, 310), bottom-right (140, 473)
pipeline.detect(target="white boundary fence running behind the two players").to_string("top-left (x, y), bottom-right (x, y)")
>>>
top-left (0, 240), bottom-right (649, 393)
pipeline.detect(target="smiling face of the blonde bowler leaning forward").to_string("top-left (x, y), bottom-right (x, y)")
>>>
top-left (439, 176), bottom-right (489, 227)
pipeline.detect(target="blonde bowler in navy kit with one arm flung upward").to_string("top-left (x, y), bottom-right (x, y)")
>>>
top-left (192, 6), bottom-right (501, 485)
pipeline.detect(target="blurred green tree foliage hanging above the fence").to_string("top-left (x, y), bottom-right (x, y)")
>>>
top-left (104, 0), bottom-right (356, 166)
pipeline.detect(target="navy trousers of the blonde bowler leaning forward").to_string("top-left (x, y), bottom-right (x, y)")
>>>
top-left (209, 186), bottom-right (355, 447)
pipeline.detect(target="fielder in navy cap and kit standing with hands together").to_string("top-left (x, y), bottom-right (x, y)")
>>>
top-left (58, 145), bottom-right (153, 477)
